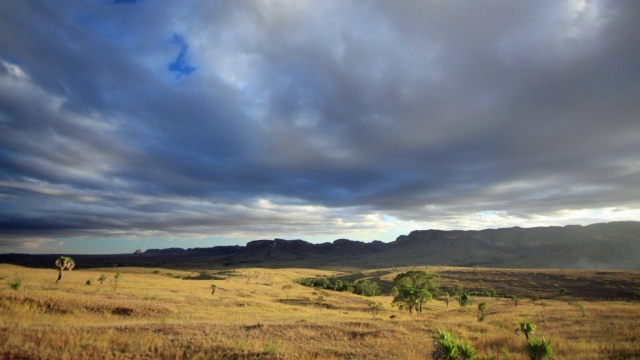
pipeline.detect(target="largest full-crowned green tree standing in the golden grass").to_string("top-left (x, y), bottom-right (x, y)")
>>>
top-left (392, 270), bottom-right (440, 314)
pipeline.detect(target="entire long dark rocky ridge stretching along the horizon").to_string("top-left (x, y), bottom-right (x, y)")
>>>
top-left (0, 221), bottom-right (640, 270)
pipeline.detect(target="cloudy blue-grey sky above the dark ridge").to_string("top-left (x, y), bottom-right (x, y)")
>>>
top-left (0, 0), bottom-right (640, 253)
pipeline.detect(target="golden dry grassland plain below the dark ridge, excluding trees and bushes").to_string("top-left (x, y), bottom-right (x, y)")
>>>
top-left (0, 264), bottom-right (640, 359)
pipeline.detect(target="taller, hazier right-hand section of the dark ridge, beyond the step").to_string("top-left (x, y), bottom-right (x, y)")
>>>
top-left (380, 222), bottom-right (640, 269)
